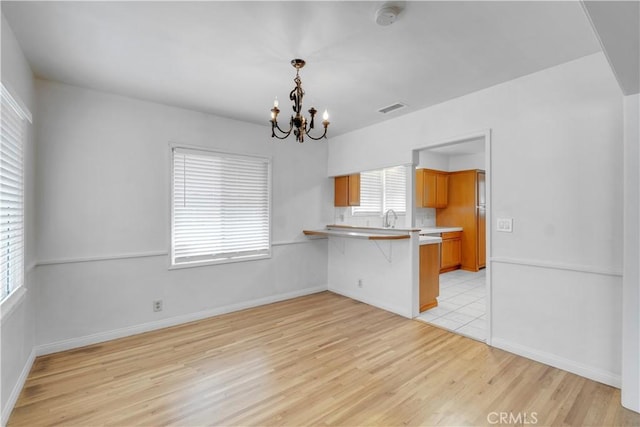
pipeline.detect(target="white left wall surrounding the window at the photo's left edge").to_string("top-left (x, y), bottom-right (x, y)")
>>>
top-left (0, 11), bottom-right (37, 425)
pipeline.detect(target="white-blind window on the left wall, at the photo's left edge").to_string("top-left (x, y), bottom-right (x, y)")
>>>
top-left (0, 84), bottom-right (31, 301)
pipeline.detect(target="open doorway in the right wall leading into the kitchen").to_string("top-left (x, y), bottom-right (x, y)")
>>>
top-left (413, 130), bottom-right (491, 343)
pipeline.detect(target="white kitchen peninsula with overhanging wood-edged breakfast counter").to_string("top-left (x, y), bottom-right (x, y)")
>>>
top-left (303, 225), bottom-right (442, 318)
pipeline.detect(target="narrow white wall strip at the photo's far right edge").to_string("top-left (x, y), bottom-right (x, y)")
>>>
top-left (622, 94), bottom-right (640, 412)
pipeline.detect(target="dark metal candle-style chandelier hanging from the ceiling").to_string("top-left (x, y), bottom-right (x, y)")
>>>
top-left (271, 59), bottom-right (329, 143)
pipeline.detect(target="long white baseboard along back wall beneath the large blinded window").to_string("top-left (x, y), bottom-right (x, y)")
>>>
top-left (35, 286), bottom-right (327, 356)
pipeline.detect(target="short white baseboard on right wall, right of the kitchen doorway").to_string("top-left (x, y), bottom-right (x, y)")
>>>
top-left (491, 337), bottom-right (622, 388)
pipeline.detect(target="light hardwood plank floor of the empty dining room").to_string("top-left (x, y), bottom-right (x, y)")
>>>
top-left (9, 292), bottom-right (640, 426)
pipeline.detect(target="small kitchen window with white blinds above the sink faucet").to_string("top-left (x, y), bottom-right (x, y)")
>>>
top-left (352, 166), bottom-right (407, 215)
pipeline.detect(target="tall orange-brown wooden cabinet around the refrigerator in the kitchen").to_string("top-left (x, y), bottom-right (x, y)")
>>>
top-left (436, 169), bottom-right (487, 271)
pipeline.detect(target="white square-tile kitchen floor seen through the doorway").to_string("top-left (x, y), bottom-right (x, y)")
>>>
top-left (417, 270), bottom-right (487, 341)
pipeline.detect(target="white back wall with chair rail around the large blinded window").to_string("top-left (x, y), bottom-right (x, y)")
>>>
top-left (36, 80), bottom-right (333, 353)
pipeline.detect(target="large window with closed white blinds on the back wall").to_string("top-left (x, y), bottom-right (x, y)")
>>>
top-left (171, 147), bottom-right (271, 266)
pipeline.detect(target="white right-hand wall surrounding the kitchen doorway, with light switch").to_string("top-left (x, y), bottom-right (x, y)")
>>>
top-left (328, 53), bottom-right (623, 386)
